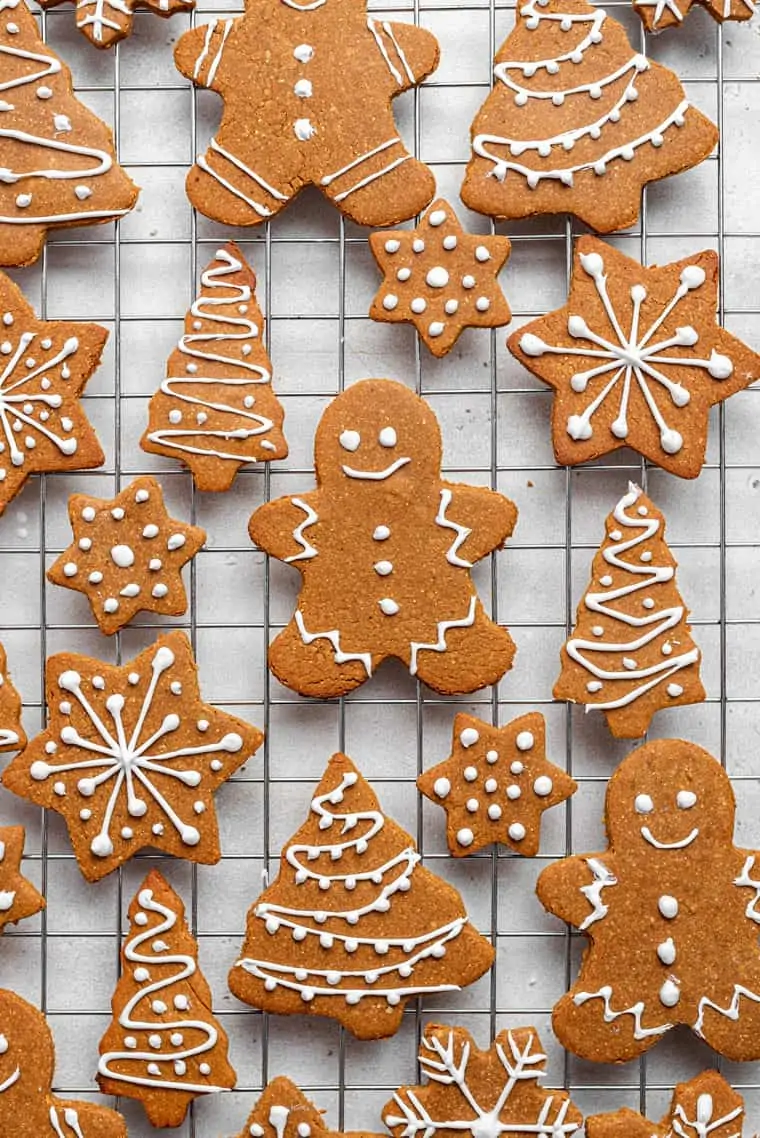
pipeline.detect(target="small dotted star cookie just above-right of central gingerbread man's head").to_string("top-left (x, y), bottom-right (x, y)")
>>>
top-left (370, 198), bottom-right (512, 356)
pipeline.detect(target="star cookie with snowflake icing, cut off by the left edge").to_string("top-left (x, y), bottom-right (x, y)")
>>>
top-left (0, 266), bottom-right (108, 514)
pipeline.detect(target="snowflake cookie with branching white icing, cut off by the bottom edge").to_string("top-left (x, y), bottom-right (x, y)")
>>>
top-left (382, 1023), bottom-right (583, 1138)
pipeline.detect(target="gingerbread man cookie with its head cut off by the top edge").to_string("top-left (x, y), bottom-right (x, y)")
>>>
top-left (174, 0), bottom-right (439, 225)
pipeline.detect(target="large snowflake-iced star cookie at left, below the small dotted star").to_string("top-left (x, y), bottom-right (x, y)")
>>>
top-left (2, 632), bottom-right (263, 881)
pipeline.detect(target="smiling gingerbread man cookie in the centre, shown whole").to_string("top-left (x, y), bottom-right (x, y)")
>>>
top-left (249, 379), bottom-right (518, 699)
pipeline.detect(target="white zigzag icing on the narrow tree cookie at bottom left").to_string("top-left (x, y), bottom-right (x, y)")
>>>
top-left (98, 889), bottom-right (225, 1095)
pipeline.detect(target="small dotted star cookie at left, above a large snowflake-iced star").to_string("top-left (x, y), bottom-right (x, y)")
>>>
top-left (48, 477), bottom-right (206, 636)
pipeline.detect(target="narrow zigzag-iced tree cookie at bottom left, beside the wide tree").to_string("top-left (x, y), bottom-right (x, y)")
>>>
top-left (98, 869), bottom-right (236, 1127)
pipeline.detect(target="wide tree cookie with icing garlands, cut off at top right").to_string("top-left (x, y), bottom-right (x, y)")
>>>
top-left (462, 0), bottom-right (718, 233)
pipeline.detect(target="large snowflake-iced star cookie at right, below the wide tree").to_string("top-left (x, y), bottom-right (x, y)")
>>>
top-left (507, 237), bottom-right (760, 478)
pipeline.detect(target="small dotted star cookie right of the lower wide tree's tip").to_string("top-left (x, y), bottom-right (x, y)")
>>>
top-left (416, 711), bottom-right (578, 857)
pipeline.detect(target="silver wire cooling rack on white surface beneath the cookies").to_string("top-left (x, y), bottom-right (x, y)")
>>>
top-left (0, 0), bottom-right (760, 1138)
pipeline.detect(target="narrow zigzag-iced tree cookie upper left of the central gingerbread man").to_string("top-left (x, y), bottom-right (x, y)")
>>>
top-left (140, 244), bottom-right (288, 490)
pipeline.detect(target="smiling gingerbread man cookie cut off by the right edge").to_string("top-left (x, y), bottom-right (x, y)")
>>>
top-left (537, 739), bottom-right (760, 1063)
